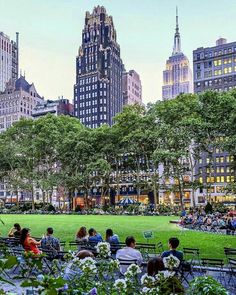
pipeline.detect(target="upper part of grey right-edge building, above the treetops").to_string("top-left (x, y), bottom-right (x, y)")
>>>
top-left (193, 38), bottom-right (236, 93)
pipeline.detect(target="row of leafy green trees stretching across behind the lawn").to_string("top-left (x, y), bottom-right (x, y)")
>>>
top-left (0, 90), bottom-right (236, 211)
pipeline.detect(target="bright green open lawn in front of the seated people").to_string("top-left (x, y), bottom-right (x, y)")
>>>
top-left (0, 215), bottom-right (236, 258)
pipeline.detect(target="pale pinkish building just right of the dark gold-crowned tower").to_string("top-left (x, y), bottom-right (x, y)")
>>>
top-left (122, 70), bottom-right (142, 105)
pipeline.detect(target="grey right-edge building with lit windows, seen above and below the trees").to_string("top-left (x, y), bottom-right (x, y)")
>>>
top-left (193, 38), bottom-right (236, 204)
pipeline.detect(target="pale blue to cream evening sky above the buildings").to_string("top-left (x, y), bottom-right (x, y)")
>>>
top-left (0, 0), bottom-right (236, 103)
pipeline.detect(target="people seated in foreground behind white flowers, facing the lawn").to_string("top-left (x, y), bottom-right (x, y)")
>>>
top-left (5, 223), bottom-right (183, 280)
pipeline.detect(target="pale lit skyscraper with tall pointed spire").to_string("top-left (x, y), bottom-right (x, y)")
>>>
top-left (162, 9), bottom-right (193, 100)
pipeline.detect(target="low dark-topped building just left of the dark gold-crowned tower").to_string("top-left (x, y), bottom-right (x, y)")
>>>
top-left (32, 98), bottom-right (74, 119)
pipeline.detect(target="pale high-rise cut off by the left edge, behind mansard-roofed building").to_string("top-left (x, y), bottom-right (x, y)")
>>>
top-left (0, 32), bottom-right (19, 93)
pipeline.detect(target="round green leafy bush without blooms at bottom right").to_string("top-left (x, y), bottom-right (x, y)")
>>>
top-left (187, 277), bottom-right (228, 295)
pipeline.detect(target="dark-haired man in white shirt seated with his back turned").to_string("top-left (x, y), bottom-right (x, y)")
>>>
top-left (116, 236), bottom-right (143, 274)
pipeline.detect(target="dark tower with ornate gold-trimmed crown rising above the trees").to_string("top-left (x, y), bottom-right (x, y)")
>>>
top-left (74, 6), bottom-right (123, 128)
